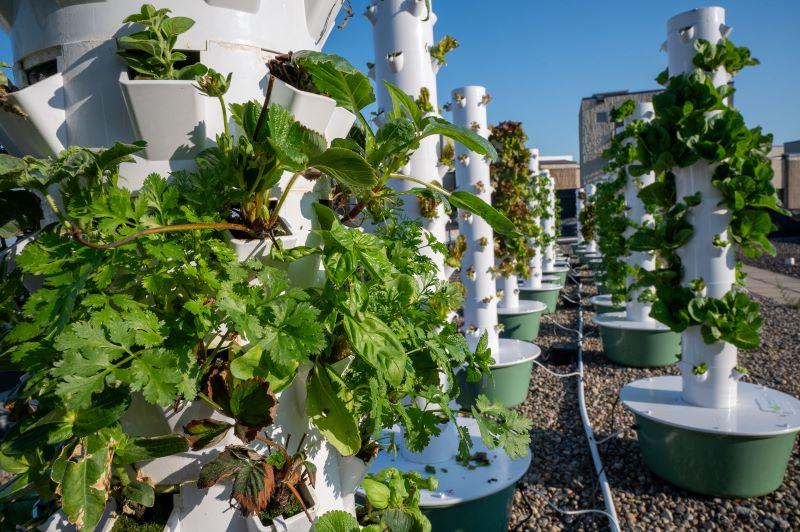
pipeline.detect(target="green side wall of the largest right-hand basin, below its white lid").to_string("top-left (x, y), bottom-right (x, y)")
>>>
top-left (636, 416), bottom-right (797, 498)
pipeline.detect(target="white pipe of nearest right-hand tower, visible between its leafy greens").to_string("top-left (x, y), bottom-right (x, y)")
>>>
top-left (667, 7), bottom-right (737, 408)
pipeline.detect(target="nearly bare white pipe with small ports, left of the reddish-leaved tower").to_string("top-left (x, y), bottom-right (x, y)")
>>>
top-left (452, 85), bottom-right (499, 361)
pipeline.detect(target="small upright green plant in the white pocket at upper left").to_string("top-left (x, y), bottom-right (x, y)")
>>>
top-left (117, 4), bottom-right (206, 80)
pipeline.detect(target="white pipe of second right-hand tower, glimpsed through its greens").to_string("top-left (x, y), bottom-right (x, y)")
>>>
top-left (623, 102), bottom-right (656, 323)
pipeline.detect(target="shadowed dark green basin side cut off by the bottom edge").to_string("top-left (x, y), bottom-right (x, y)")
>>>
top-left (421, 484), bottom-right (516, 532)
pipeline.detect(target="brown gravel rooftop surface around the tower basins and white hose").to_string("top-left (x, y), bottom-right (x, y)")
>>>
top-left (510, 258), bottom-right (800, 531)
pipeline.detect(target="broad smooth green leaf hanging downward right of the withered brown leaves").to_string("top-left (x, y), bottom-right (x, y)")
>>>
top-left (306, 365), bottom-right (361, 456)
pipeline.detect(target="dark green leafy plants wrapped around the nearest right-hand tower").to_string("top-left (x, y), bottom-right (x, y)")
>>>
top-left (630, 39), bottom-right (784, 349)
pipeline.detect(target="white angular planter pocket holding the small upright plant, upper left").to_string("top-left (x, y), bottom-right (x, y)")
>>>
top-left (119, 72), bottom-right (211, 164)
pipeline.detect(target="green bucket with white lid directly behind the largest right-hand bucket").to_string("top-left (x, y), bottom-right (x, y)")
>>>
top-left (594, 312), bottom-right (681, 368)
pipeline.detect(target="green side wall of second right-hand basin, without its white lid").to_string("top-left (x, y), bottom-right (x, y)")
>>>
top-left (600, 326), bottom-right (681, 368)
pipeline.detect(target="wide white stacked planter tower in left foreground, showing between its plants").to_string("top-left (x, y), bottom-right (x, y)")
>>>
top-left (0, 0), bottom-right (378, 530)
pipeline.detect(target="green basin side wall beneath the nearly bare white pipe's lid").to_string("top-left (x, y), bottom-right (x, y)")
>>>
top-left (456, 360), bottom-right (533, 409)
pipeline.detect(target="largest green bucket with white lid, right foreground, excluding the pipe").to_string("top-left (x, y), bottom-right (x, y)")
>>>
top-left (620, 376), bottom-right (800, 498)
